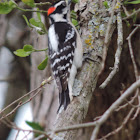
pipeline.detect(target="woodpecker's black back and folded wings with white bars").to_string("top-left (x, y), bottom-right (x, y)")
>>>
top-left (48, 22), bottom-right (76, 93)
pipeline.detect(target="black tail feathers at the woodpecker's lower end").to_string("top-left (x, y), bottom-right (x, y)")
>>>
top-left (57, 88), bottom-right (70, 113)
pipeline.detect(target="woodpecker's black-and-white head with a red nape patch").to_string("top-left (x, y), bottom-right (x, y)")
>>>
top-left (48, 0), bottom-right (71, 23)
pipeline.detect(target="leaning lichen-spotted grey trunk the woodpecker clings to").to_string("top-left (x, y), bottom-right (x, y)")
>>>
top-left (53, 0), bottom-right (114, 140)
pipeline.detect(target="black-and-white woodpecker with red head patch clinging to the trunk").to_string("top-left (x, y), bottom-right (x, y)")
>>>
top-left (48, 1), bottom-right (83, 112)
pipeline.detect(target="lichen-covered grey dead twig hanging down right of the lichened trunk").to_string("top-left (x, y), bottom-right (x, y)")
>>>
top-left (100, 11), bottom-right (123, 89)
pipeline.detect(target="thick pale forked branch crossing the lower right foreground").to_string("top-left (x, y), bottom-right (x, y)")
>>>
top-left (52, 80), bottom-right (140, 140)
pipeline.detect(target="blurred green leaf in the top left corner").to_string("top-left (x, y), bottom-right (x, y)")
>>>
top-left (0, 1), bottom-right (16, 14)
